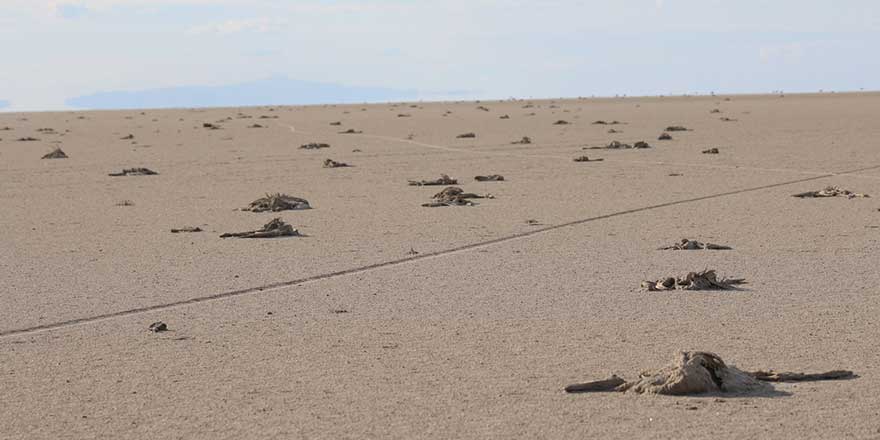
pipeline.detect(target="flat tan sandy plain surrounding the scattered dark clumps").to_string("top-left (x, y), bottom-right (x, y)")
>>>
top-left (0, 94), bottom-right (880, 439)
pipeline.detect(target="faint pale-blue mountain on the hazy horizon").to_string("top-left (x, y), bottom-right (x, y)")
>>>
top-left (66, 78), bottom-right (419, 110)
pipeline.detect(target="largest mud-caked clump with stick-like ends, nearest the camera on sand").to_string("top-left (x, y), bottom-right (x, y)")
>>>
top-left (565, 351), bottom-right (856, 396)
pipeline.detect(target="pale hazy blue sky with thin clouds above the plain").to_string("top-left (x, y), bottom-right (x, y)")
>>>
top-left (0, 0), bottom-right (880, 110)
